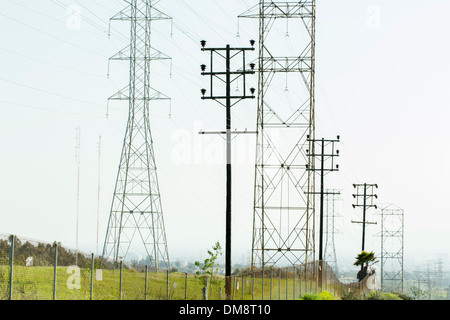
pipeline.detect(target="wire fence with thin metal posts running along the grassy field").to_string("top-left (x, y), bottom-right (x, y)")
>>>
top-left (0, 235), bottom-right (372, 300)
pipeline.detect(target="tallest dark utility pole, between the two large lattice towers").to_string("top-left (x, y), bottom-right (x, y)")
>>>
top-left (200, 40), bottom-right (255, 299)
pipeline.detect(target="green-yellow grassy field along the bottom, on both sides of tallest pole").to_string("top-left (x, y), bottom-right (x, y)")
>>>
top-left (0, 266), bottom-right (356, 300)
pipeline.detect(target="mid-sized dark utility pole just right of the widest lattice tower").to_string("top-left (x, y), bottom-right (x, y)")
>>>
top-left (306, 135), bottom-right (340, 287)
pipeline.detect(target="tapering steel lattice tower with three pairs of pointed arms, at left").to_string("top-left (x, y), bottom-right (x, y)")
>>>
top-left (103, 0), bottom-right (171, 270)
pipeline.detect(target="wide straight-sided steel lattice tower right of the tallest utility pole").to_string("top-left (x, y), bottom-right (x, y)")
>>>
top-left (239, 0), bottom-right (316, 268)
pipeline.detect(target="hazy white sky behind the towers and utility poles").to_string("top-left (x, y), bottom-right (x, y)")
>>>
top-left (0, 0), bottom-right (450, 270)
